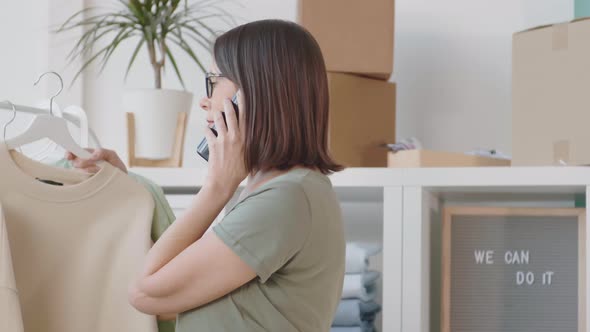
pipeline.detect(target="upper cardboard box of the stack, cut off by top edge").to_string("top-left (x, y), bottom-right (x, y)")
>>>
top-left (299, 0), bottom-right (394, 80)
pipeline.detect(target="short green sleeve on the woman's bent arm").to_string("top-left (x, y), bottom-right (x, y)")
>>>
top-left (213, 183), bottom-right (311, 282)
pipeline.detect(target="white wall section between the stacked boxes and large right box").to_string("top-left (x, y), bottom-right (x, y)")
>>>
top-left (392, 0), bottom-right (573, 153)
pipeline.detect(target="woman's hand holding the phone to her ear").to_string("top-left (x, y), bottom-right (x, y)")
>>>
top-left (205, 91), bottom-right (248, 195)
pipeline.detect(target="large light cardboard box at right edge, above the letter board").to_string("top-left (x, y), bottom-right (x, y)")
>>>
top-left (512, 18), bottom-right (590, 166)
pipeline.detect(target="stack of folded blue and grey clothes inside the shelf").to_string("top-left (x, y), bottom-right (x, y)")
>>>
top-left (331, 242), bottom-right (381, 332)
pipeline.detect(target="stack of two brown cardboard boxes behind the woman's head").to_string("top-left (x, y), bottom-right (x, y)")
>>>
top-left (299, 0), bottom-right (396, 167)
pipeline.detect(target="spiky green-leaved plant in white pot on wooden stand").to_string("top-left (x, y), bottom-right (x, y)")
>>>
top-left (57, 0), bottom-right (235, 159)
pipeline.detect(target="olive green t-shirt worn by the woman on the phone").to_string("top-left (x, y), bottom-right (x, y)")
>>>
top-left (176, 168), bottom-right (345, 332)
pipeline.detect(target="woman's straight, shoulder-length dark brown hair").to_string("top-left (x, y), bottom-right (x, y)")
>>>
top-left (213, 20), bottom-right (343, 174)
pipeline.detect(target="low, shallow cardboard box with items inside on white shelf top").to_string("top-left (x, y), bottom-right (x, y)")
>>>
top-left (387, 150), bottom-right (510, 168)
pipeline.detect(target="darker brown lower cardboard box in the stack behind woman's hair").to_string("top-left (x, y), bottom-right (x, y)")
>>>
top-left (328, 73), bottom-right (396, 167)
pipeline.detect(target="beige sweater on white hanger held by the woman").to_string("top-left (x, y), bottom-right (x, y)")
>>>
top-left (0, 143), bottom-right (157, 332)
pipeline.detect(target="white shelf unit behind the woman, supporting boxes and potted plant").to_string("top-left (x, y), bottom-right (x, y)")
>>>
top-left (131, 167), bottom-right (590, 332)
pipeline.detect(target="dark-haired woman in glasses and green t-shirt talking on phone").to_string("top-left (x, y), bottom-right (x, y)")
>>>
top-left (71, 20), bottom-right (345, 332)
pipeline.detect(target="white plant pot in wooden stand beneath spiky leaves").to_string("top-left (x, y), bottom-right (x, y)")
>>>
top-left (123, 89), bottom-right (193, 159)
